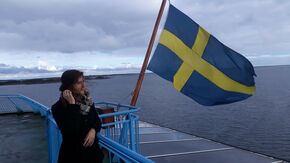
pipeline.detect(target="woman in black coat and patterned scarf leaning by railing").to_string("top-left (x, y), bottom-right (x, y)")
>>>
top-left (51, 70), bottom-right (103, 163)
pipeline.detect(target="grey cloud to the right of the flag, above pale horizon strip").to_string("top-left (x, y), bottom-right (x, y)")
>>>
top-left (176, 0), bottom-right (290, 56)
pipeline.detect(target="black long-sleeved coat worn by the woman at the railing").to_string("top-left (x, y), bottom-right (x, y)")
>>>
top-left (51, 99), bottom-right (103, 163)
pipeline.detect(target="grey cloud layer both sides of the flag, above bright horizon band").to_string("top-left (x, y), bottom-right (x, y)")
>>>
top-left (0, 0), bottom-right (290, 56)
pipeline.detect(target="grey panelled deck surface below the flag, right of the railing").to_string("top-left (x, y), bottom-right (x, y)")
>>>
top-left (140, 122), bottom-right (282, 163)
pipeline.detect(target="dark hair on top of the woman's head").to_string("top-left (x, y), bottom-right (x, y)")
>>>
top-left (59, 69), bottom-right (84, 92)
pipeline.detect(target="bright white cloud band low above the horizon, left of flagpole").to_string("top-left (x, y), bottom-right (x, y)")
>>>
top-left (0, 51), bottom-right (142, 80)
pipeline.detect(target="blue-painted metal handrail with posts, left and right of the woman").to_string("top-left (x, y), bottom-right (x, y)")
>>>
top-left (0, 94), bottom-right (153, 163)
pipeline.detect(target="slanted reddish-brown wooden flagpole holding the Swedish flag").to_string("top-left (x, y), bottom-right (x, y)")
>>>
top-left (130, 0), bottom-right (167, 106)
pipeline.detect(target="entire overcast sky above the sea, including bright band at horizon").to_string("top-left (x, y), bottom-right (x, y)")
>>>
top-left (0, 0), bottom-right (290, 79)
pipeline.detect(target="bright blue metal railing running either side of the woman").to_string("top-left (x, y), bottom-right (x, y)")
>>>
top-left (0, 95), bottom-right (153, 163)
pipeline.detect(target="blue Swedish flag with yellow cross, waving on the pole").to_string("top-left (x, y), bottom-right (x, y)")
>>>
top-left (147, 5), bottom-right (256, 106)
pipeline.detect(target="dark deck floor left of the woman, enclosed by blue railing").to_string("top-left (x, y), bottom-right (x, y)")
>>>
top-left (0, 113), bottom-right (48, 163)
